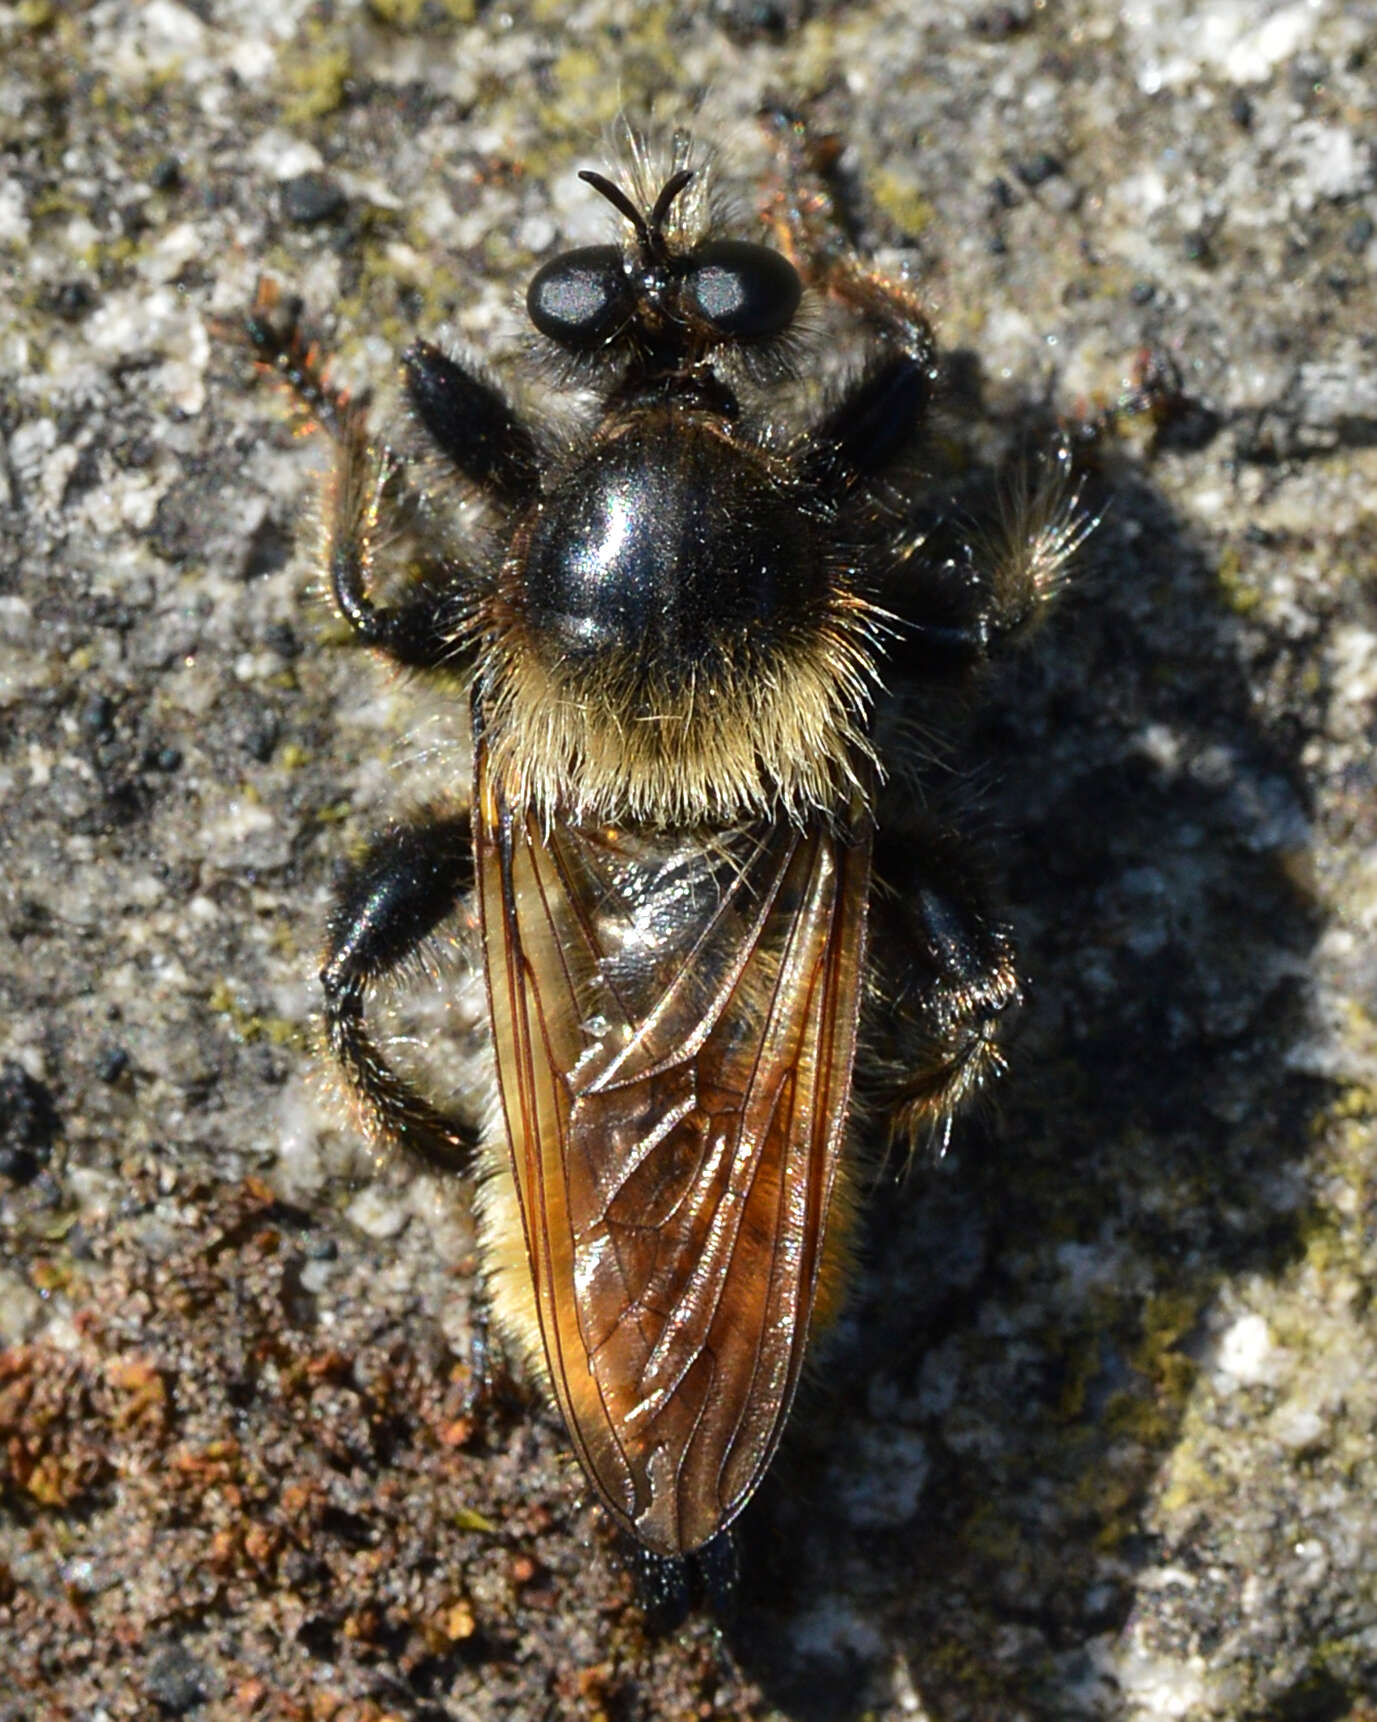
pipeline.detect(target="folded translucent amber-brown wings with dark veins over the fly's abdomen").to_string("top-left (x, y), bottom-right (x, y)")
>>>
top-left (475, 749), bottom-right (869, 1555)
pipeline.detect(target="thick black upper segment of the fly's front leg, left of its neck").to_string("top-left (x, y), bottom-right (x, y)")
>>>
top-left (401, 341), bottom-right (539, 505)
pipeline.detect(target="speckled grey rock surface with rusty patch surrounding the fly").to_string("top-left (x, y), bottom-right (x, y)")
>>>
top-left (0, 0), bottom-right (1377, 1722)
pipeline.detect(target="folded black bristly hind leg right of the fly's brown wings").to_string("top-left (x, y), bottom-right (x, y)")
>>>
top-left (862, 820), bottom-right (1021, 1154)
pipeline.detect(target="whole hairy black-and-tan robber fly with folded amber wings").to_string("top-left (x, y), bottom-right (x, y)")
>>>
top-left (239, 127), bottom-right (1083, 1557)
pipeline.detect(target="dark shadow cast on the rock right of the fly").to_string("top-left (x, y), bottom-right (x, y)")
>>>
top-left (716, 356), bottom-right (1324, 1722)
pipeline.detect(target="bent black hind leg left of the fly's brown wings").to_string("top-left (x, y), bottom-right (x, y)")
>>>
top-left (320, 815), bottom-right (477, 1174)
